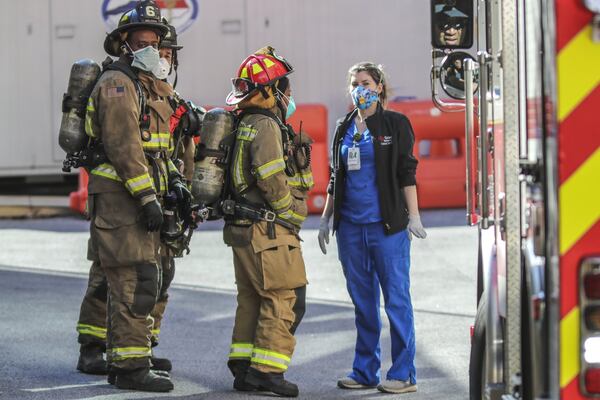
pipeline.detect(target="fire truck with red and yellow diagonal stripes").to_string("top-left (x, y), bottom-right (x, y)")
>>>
top-left (431, 0), bottom-right (600, 400)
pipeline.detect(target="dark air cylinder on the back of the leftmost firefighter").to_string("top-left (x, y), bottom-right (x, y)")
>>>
top-left (58, 59), bottom-right (101, 154)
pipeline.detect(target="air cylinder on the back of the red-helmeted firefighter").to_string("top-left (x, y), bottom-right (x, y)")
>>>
top-left (192, 108), bottom-right (235, 206)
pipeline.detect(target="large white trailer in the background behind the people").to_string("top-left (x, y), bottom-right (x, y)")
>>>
top-left (0, 0), bottom-right (430, 178)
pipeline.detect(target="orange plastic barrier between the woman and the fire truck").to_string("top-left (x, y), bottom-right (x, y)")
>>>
top-left (388, 100), bottom-right (466, 208)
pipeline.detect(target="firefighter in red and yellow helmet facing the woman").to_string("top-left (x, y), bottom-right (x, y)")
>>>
top-left (223, 47), bottom-right (313, 397)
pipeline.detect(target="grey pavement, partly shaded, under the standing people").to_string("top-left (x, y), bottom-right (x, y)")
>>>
top-left (0, 212), bottom-right (476, 400)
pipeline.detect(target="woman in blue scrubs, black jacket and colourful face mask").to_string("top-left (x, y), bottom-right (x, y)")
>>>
top-left (319, 62), bottom-right (427, 393)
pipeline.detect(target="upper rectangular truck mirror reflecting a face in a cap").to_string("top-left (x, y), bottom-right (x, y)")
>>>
top-left (431, 0), bottom-right (474, 49)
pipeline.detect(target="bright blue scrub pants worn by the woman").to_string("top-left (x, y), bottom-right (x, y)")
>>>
top-left (337, 218), bottom-right (416, 386)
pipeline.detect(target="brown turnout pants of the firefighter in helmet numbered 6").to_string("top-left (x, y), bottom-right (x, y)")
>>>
top-left (80, 192), bottom-right (160, 370)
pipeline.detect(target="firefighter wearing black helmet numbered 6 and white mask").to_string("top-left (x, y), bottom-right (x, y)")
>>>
top-left (77, 0), bottom-right (183, 392)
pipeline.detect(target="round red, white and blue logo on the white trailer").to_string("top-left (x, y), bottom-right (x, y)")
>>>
top-left (102, 0), bottom-right (198, 34)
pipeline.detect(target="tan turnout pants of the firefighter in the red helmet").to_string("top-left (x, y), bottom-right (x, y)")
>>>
top-left (226, 222), bottom-right (307, 372)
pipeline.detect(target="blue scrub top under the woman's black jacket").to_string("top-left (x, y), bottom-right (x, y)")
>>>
top-left (340, 120), bottom-right (382, 224)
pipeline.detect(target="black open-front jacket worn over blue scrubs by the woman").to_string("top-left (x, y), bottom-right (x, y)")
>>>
top-left (327, 106), bottom-right (418, 235)
